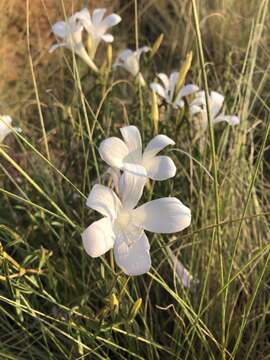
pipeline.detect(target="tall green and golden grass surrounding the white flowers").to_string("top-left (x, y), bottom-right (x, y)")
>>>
top-left (0, 0), bottom-right (270, 360)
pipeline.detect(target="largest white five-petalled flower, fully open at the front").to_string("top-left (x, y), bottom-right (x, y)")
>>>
top-left (82, 165), bottom-right (191, 275)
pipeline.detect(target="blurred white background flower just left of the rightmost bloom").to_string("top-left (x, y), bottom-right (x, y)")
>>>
top-left (150, 72), bottom-right (199, 108)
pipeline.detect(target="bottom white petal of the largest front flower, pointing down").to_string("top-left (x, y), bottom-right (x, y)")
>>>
top-left (114, 230), bottom-right (151, 276)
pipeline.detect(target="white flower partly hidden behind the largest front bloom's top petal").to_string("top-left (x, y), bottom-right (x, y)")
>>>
top-left (99, 126), bottom-right (176, 180)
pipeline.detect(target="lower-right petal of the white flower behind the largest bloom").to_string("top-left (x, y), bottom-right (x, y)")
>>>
top-left (143, 156), bottom-right (176, 181)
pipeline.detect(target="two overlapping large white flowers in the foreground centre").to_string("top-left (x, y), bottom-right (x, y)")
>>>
top-left (82, 126), bottom-right (191, 275)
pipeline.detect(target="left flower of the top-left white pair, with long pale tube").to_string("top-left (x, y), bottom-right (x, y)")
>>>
top-left (49, 14), bottom-right (98, 72)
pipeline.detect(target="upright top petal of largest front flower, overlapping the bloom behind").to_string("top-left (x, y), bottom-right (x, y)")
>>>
top-left (119, 164), bottom-right (147, 209)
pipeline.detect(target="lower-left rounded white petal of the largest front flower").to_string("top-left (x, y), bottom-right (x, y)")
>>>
top-left (81, 218), bottom-right (115, 257)
